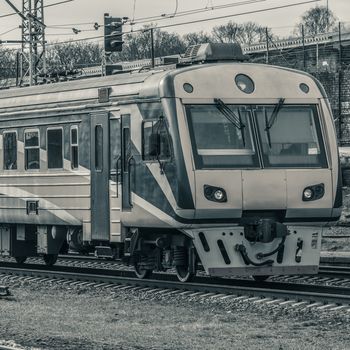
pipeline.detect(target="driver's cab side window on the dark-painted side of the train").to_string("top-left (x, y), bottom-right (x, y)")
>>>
top-left (142, 118), bottom-right (171, 161)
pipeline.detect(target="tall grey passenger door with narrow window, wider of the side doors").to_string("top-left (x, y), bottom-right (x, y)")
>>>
top-left (90, 112), bottom-right (109, 241)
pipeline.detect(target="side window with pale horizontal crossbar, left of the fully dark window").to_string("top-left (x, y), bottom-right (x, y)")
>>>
top-left (24, 130), bottom-right (40, 170)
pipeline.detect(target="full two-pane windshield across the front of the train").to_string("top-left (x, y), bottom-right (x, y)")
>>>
top-left (186, 100), bottom-right (327, 169)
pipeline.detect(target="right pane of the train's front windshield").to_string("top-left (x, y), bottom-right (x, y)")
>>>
top-left (254, 105), bottom-right (327, 167)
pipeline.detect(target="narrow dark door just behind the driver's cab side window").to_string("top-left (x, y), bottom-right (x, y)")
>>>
top-left (121, 115), bottom-right (134, 211)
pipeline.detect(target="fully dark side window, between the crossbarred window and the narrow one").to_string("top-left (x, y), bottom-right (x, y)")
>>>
top-left (47, 128), bottom-right (63, 169)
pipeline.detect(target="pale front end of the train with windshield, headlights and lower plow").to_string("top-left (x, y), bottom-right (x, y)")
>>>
top-left (164, 44), bottom-right (342, 278)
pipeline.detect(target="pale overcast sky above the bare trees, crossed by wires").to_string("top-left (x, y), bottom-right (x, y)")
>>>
top-left (0, 0), bottom-right (350, 47)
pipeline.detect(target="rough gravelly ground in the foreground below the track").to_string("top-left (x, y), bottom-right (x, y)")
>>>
top-left (0, 282), bottom-right (350, 350)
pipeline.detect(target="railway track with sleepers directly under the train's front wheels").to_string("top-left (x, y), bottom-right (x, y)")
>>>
top-left (0, 262), bottom-right (350, 310)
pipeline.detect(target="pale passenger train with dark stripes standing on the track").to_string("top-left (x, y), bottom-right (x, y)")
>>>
top-left (0, 44), bottom-right (342, 282)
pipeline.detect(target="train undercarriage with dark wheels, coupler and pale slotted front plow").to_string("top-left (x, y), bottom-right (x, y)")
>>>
top-left (0, 218), bottom-right (322, 282)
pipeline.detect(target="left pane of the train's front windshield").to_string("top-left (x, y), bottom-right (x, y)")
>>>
top-left (186, 104), bottom-right (259, 168)
